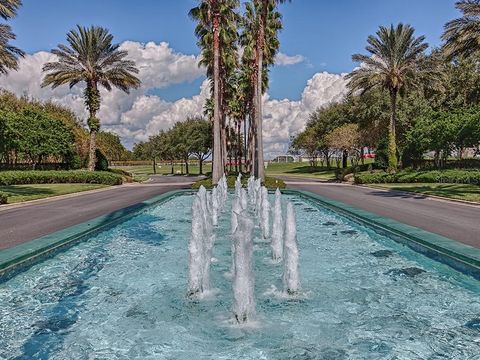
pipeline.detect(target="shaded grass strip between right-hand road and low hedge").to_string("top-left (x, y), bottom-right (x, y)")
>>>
top-left (369, 183), bottom-right (480, 202)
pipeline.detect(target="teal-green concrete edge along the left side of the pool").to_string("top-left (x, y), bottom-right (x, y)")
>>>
top-left (0, 189), bottom-right (192, 282)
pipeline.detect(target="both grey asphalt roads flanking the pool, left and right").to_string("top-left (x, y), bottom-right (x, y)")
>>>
top-left (0, 176), bottom-right (480, 249)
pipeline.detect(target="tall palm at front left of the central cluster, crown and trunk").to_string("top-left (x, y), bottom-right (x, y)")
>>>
top-left (189, 0), bottom-right (239, 184)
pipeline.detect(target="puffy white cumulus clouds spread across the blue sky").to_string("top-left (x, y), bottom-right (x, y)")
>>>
top-left (0, 41), bottom-right (347, 158)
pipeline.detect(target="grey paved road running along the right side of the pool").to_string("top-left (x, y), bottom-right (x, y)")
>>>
top-left (286, 179), bottom-right (480, 248)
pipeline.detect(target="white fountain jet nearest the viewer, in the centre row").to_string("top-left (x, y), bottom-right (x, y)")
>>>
top-left (232, 212), bottom-right (255, 324)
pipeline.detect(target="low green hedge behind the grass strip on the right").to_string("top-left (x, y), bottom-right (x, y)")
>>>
top-left (355, 170), bottom-right (480, 185)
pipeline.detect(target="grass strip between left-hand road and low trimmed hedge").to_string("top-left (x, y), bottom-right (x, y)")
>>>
top-left (0, 184), bottom-right (107, 204)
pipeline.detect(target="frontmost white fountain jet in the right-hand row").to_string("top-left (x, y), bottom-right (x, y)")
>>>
top-left (283, 202), bottom-right (300, 295)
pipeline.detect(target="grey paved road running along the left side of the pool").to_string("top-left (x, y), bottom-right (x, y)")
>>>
top-left (0, 176), bottom-right (198, 249)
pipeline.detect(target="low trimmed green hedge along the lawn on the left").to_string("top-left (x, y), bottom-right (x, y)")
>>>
top-left (0, 170), bottom-right (123, 185)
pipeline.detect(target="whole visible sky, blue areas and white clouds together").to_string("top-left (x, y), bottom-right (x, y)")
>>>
top-left (0, 0), bottom-right (459, 156)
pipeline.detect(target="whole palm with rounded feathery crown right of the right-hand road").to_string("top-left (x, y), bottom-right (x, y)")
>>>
top-left (347, 23), bottom-right (428, 172)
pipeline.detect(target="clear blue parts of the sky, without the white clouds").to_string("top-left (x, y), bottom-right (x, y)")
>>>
top-left (11, 0), bottom-right (458, 101)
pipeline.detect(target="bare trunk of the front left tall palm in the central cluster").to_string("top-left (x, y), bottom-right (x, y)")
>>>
top-left (212, 15), bottom-right (223, 184)
